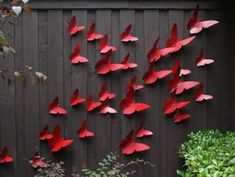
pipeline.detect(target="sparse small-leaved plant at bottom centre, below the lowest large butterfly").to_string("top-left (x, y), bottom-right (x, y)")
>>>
top-left (74, 153), bottom-right (155, 177)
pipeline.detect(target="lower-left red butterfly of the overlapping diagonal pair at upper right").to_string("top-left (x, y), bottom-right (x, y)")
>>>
top-left (147, 37), bottom-right (174, 63)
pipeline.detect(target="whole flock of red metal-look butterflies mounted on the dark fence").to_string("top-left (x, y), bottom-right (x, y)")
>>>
top-left (0, 5), bottom-right (219, 163)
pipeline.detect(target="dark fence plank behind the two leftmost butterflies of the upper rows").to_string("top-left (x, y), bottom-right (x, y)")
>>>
top-left (68, 10), bottom-right (90, 174)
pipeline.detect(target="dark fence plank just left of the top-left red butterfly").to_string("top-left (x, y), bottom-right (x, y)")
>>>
top-left (61, 11), bottom-right (72, 176)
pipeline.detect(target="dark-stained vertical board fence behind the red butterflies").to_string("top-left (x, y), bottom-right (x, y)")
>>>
top-left (0, 0), bottom-right (235, 177)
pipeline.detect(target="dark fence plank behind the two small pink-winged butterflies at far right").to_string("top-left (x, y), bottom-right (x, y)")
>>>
top-left (184, 11), bottom-right (207, 132)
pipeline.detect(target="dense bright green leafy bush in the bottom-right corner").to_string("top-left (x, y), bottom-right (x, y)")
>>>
top-left (177, 130), bottom-right (235, 177)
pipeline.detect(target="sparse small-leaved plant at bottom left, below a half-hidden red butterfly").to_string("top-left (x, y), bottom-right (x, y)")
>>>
top-left (34, 161), bottom-right (65, 177)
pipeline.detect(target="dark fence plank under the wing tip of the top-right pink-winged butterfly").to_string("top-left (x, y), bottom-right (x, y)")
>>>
top-left (205, 11), bottom-right (230, 130)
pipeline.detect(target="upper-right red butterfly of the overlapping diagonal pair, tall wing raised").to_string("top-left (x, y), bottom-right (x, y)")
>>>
top-left (166, 23), bottom-right (196, 53)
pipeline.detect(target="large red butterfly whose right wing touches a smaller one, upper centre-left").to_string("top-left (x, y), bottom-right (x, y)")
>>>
top-left (95, 50), bottom-right (124, 74)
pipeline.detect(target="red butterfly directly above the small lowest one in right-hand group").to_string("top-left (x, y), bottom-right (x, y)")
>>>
top-left (163, 91), bottom-right (191, 114)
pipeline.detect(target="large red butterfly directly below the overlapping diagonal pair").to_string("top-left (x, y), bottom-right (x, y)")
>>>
top-left (142, 65), bottom-right (171, 84)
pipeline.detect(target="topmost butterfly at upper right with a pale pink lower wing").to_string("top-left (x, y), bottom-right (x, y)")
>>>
top-left (187, 5), bottom-right (219, 34)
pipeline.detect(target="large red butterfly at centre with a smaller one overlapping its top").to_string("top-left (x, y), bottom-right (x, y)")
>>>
top-left (120, 88), bottom-right (150, 115)
